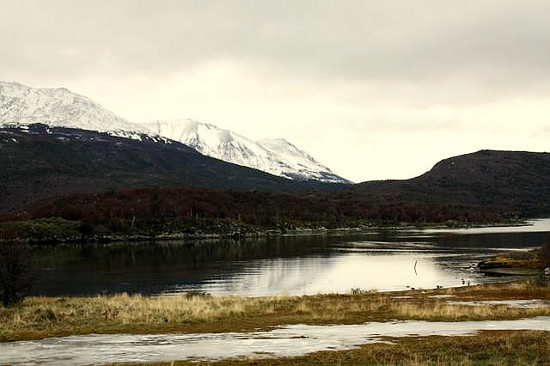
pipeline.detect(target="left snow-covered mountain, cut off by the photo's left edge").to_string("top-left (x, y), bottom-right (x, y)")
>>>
top-left (0, 82), bottom-right (150, 138)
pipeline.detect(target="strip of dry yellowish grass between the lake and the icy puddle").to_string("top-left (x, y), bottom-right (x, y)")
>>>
top-left (0, 283), bottom-right (550, 341)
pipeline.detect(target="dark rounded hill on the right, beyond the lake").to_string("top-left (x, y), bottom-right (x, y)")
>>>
top-left (352, 150), bottom-right (550, 216)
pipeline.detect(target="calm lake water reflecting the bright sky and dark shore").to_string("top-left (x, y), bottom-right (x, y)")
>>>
top-left (33, 219), bottom-right (550, 296)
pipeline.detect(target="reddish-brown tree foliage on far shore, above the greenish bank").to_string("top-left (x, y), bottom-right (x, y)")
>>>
top-left (0, 188), bottom-right (508, 227)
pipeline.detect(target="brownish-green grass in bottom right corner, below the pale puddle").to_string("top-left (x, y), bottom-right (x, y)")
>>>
top-left (140, 331), bottom-right (550, 366)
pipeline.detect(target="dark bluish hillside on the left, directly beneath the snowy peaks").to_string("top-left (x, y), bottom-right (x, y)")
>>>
top-left (0, 124), bottom-right (340, 210)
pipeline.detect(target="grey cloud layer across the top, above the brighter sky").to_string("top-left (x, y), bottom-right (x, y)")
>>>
top-left (0, 0), bottom-right (550, 102)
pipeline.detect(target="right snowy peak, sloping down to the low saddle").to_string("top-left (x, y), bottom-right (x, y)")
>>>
top-left (145, 119), bottom-right (350, 183)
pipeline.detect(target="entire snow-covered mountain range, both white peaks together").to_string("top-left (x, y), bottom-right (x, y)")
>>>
top-left (0, 81), bottom-right (351, 183)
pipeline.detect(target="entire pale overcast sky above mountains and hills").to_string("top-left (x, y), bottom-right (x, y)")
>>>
top-left (0, 0), bottom-right (550, 182)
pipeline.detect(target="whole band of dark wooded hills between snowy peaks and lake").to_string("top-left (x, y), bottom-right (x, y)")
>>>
top-left (0, 125), bottom-right (550, 241)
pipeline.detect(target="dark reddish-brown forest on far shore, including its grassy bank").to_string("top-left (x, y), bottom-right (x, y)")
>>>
top-left (0, 188), bottom-right (514, 239)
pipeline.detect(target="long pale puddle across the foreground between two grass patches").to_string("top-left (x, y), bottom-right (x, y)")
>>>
top-left (0, 317), bottom-right (550, 365)
